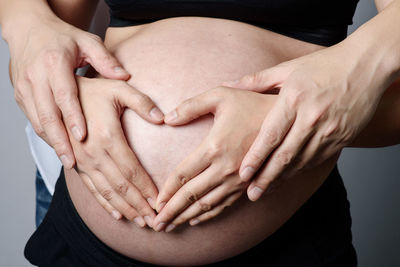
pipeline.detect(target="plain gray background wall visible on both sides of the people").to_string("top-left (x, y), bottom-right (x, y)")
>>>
top-left (0, 0), bottom-right (400, 267)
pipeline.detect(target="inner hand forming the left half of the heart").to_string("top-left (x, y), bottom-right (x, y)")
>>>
top-left (71, 77), bottom-right (164, 227)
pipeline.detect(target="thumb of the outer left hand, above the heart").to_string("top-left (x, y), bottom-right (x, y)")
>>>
top-left (80, 37), bottom-right (130, 81)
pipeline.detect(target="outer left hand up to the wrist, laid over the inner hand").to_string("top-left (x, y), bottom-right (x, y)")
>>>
top-left (7, 13), bottom-right (129, 168)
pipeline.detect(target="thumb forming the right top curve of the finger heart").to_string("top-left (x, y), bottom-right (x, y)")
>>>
top-left (164, 89), bottom-right (218, 125)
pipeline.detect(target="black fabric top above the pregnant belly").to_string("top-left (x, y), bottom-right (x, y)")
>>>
top-left (105, 0), bottom-right (358, 46)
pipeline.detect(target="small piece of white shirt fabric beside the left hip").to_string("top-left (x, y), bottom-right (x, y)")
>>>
top-left (25, 122), bottom-right (62, 195)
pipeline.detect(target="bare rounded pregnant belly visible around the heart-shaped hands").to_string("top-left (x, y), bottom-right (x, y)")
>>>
top-left (66, 17), bottom-right (335, 266)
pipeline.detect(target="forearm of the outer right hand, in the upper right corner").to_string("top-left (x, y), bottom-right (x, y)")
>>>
top-left (339, 0), bottom-right (400, 93)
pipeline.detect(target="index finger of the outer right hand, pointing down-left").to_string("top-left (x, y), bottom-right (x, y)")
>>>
top-left (239, 96), bottom-right (296, 182)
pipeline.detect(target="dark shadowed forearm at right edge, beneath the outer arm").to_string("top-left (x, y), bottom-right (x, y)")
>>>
top-left (350, 78), bottom-right (400, 147)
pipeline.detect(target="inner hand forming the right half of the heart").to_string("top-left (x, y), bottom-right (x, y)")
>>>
top-left (153, 87), bottom-right (276, 231)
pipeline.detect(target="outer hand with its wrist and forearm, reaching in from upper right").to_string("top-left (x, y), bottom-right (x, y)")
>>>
top-left (231, 0), bottom-right (400, 201)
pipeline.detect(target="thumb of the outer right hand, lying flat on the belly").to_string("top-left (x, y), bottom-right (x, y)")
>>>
top-left (222, 66), bottom-right (287, 92)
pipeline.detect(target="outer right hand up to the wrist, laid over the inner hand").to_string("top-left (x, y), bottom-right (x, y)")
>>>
top-left (224, 43), bottom-right (386, 201)
